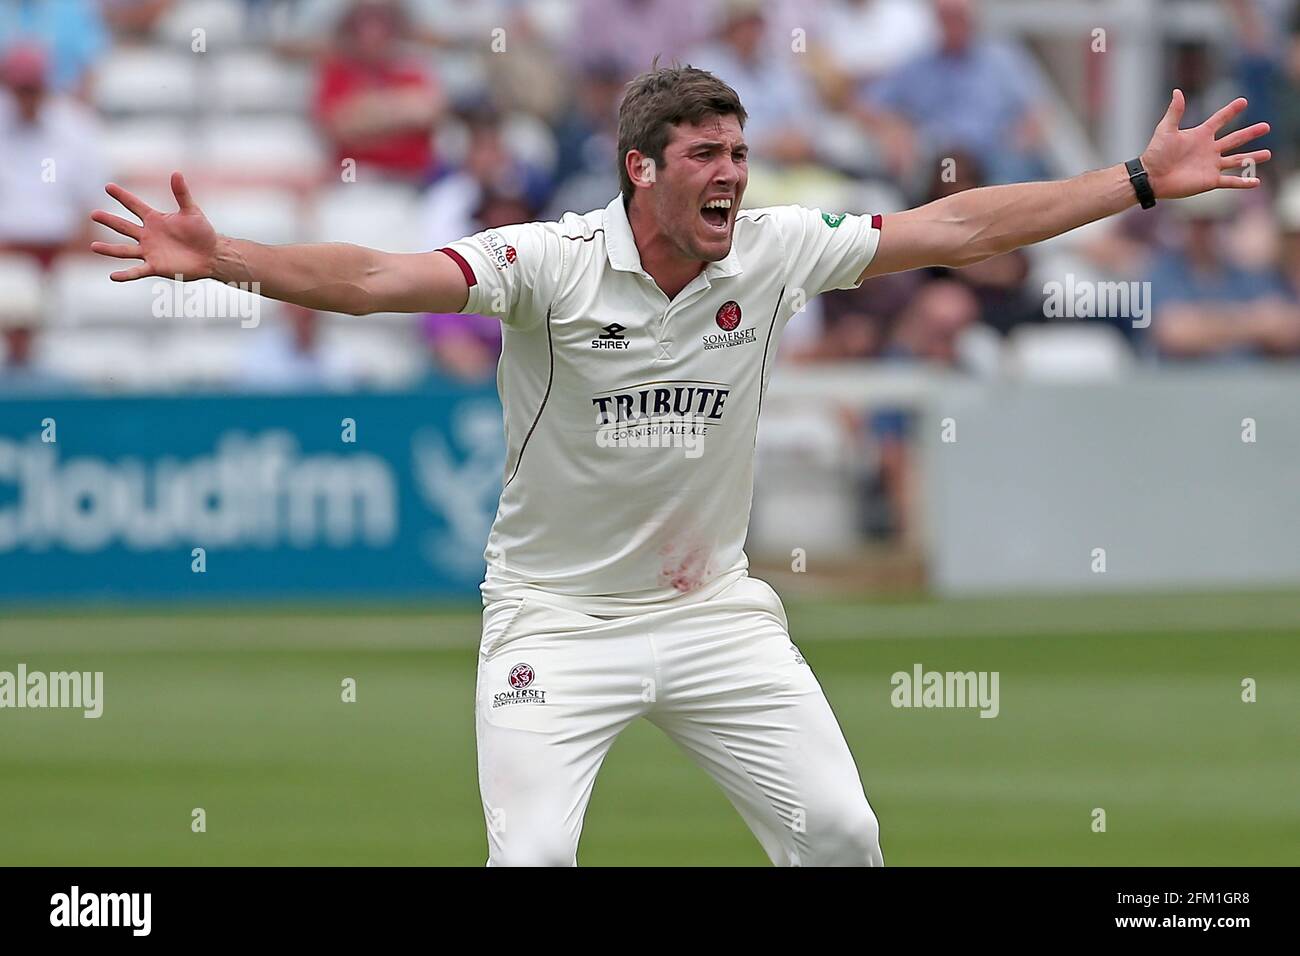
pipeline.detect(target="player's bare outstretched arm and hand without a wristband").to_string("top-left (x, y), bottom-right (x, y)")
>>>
top-left (90, 173), bottom-right (469, 315)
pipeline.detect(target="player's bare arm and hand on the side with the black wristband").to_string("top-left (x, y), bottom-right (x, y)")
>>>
top-left (862, 90), bottom-right (1271, 278)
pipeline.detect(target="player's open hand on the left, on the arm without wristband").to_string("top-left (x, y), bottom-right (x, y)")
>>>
top-left (90, 173), bottom-right (220, 282)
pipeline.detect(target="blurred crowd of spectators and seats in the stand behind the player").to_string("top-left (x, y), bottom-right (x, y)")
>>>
top-left (0, 0), bottom-right (1300, 395)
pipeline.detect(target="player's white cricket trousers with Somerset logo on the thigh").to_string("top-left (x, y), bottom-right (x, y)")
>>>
top-left (475, 576), bottom-right (884, 866)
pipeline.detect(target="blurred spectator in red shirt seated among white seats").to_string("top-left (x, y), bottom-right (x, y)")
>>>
top-left (316, 0), bottom-right (443, 183)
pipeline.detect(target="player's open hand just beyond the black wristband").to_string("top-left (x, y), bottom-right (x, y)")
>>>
top-left (1141, 90), bottom-right (1273, 199)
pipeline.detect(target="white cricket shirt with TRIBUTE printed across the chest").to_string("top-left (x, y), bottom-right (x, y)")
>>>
top-left (442, 196), bottom-right (880, 613)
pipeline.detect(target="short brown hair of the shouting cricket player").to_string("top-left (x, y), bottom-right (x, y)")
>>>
top-left (619, 57), bottom-right (746, 206)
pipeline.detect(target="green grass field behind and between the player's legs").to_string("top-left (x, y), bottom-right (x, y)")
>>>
top-left (0, 593), bottom-right (1300, 866)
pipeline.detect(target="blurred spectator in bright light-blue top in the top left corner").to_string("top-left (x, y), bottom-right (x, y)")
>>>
top-left (0, 0), bottom-right (109, 101)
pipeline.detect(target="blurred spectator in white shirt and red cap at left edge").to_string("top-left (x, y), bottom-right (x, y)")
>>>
top-left (0, 46), bottom-right (107, 267)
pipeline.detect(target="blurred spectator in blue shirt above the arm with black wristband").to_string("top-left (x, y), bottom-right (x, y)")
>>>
top-left (861, 0), bottom-right (1047, 183)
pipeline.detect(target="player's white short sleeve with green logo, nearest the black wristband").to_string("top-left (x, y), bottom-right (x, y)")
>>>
top-left (768, 206), bottom-right (881, 298)
